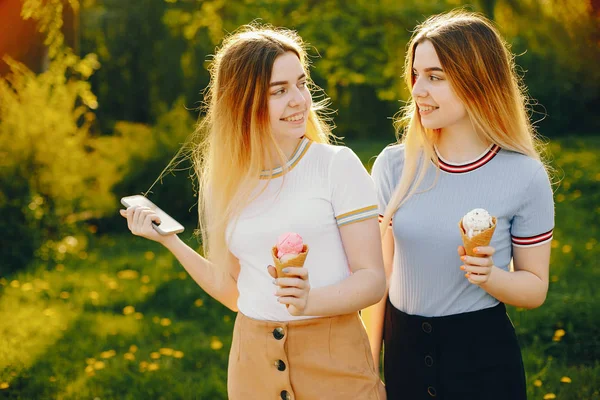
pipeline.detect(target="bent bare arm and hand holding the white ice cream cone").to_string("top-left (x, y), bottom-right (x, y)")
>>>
top-left (459, 243), bottom-right (550, 308)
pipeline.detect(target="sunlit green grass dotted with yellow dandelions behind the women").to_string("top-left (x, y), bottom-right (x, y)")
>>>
top-left (0, 137), bottom-right (600, 400)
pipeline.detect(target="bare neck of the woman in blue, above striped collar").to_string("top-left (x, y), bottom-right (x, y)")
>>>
top-left (436, 120), bottom-right (491, 164)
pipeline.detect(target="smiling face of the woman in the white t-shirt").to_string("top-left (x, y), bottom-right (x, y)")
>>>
top-left (269, 51), bottom-right (312, 140)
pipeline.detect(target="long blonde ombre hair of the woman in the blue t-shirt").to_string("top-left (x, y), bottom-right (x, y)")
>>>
top-left (381, 10), bottom-right (541, 235)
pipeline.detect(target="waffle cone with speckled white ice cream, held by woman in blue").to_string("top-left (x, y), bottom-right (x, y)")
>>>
top-left (458, 208), bottom-right (496, 257)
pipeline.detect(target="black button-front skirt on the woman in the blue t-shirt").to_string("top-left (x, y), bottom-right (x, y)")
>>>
top-left (383, 300), bottom-right (527, 400)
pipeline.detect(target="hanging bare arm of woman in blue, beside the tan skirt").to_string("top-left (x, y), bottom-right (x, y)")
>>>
top-left (362, 228), bottom-right (394, 371)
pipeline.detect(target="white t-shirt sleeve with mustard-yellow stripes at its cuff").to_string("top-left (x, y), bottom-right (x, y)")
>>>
top-left (329, 147), bottom-right (378, 227)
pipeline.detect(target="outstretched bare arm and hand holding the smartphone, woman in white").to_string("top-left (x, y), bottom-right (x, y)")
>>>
top-left (121, 207), bottom-right (240, 311)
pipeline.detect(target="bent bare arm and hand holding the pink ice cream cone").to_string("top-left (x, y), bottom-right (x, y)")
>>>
top-left (276, 218), bottom-right (385, 316)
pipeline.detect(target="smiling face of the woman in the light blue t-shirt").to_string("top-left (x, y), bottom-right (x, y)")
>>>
top-left (412, 40), bottom-right (469, 129)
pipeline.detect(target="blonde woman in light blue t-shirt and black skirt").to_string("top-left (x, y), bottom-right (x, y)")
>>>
top-left (369, 11), bottom-right (554, 400)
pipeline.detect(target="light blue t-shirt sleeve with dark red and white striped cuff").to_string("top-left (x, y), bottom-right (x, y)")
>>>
top-left (510, 167), bottom-right (554, 247)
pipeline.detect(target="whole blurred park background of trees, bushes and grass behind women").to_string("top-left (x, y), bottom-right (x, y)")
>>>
top-left (0, 0), bottom-right (600, 400)
